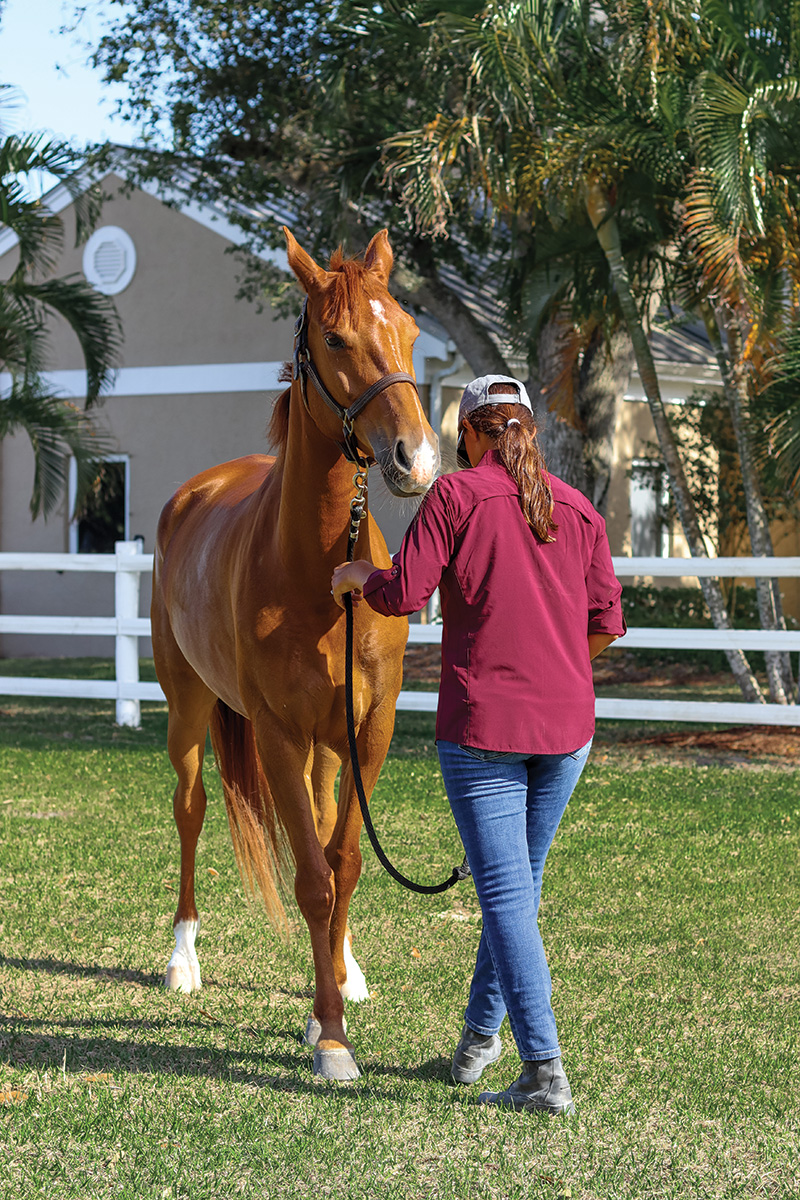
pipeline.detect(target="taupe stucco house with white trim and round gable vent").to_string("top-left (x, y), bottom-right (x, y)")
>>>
top-left (0, 173), bottom-right (788, 656)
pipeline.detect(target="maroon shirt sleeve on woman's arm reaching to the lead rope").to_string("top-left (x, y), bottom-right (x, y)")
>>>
top-left (362, 480), bottom-right (455, 617)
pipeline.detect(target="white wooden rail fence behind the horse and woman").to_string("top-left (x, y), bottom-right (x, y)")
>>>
top-left (0, 541), bottom-right (800, 726)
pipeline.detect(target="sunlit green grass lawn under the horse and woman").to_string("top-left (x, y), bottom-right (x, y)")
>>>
top-left (0, 662), bottom-right (800, 1200)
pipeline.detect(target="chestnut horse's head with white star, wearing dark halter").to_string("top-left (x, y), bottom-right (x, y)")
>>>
top-left (283, 228), bottom-right (439, 496)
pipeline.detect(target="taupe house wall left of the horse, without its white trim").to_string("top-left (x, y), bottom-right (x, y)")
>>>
top-left (0, 178), bottom-right (298, 656)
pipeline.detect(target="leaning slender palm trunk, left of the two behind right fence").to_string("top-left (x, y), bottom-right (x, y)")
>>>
top-left (585, 181), bottom-right (764, 704)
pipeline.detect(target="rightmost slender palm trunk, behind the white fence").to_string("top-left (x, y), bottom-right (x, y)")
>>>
top-left (703, 306), bottom-right (794, 704)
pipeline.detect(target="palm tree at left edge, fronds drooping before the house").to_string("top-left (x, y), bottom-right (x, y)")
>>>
top-left (0, 98), bottom-right (121, 517)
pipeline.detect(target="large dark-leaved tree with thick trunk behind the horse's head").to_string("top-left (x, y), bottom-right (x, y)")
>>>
top-left (84, 0), bottom-right (632, 508)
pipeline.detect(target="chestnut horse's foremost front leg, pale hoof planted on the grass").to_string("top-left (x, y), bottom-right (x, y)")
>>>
top-left (254, 713), bottom-right (360, 1080)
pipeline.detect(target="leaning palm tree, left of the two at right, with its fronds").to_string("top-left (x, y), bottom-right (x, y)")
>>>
top-left (387, 0), bottom-right (764, 702)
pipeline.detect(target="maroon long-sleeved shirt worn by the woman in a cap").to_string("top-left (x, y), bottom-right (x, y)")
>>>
top-left (363, 450), bottom-right (626, 755)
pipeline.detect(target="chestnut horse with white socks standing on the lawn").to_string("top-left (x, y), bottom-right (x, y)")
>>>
top-left (152, 229), bottom-right (439, 1079)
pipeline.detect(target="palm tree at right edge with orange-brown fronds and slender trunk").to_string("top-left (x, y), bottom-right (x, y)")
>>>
top-left (684, 18), bottom-right (800, 703)
